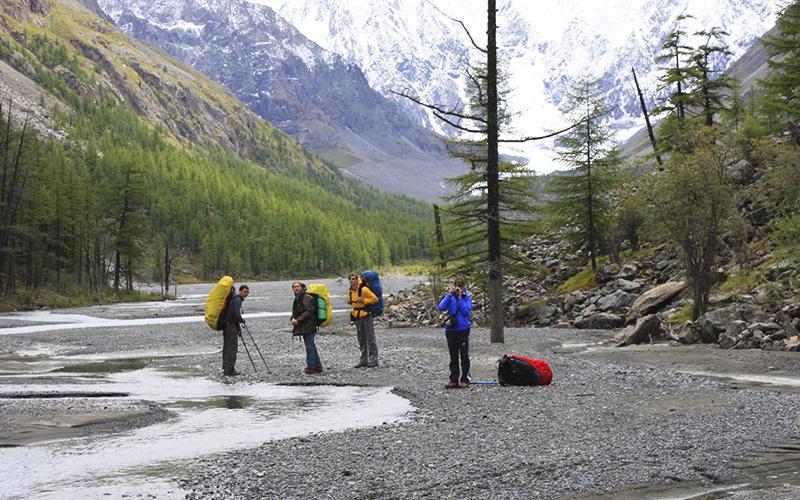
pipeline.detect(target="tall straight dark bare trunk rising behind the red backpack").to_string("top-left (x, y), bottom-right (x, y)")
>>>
top-left (486, 0), bottom-right (504, 343)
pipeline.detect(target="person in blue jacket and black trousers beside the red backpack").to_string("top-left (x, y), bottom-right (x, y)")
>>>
top-left (439, 277), bottom-right (472, 389)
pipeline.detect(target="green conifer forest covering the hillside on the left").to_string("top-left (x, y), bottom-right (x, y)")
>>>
top-left (0, 1), bottom-right (432, 303)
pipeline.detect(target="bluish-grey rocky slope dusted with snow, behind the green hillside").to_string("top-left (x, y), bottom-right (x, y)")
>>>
top-left (100, 0), bottom-right (465, 199)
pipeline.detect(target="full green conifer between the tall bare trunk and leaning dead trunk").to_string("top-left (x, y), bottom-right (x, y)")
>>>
top-left (546, 76), bottom-right (622, 269)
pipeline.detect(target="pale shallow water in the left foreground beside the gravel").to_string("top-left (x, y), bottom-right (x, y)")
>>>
top-left (0, 368), bottom-right (411, 498)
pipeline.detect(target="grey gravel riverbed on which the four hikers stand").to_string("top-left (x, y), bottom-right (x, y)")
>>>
top-left (0, 280), bottom-right (800, 499)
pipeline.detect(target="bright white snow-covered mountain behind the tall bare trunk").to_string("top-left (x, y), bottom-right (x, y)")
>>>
top-left (255, 0), bottom-right (778, 171)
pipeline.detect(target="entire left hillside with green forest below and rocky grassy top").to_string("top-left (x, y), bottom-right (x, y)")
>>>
top-left (0, 1), bottom-right (432, 304)
